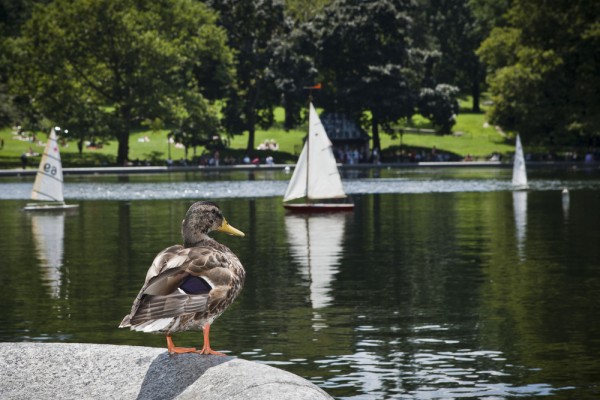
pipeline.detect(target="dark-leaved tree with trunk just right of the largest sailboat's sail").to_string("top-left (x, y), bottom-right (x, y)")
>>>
top-left (314, 0), bottom-right (419, 152)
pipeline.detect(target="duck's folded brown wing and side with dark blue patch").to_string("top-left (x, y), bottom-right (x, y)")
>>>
top-left (120, 246), bottom-right (243, 327)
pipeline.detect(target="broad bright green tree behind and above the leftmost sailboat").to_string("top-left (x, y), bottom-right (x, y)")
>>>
top-left (6, 0), bottom-right (231, 164)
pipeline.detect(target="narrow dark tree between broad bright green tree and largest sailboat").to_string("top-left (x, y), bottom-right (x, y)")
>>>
top-left (207, 0), bottom-right (284, 151)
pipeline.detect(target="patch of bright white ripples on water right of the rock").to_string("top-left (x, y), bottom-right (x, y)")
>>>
top-left (320, 325), bottom-right (556, 399)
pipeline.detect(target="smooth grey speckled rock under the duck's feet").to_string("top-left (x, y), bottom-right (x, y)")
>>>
top-left (0, 343), bottom-right (331, 400)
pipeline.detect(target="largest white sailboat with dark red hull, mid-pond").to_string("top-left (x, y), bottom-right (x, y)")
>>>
top-left (283, 103), bottom-right (354, 212)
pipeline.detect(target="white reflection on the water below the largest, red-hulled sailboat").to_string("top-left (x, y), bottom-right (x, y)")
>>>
top-left (285, 214), bottom-right (346, 309)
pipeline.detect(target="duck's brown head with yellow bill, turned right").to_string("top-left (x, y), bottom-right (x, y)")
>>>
top-left (181, 201), bottom-right (244, 247)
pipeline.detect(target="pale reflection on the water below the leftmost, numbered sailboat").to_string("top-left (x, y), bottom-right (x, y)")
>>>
top-left (31, 212), bottom-right (65, 299)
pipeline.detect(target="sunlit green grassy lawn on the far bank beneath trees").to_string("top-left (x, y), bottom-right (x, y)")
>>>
top-left (0, 100), bottom-right (514, 168)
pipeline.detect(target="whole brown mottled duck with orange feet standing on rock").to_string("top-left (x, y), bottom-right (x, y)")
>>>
top-left (119, 201), bottom-right (246, 355)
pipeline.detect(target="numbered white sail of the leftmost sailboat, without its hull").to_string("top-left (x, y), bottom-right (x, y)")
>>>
top-left (31, 129), bottom-right (64, 202)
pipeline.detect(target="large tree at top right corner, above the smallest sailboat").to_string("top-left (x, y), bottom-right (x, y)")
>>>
top-left (478, 0), bottom-right (600, 144)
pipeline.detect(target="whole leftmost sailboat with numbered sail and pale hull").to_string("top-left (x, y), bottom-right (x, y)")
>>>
top-left (24, 128), bottom-right (78, 211)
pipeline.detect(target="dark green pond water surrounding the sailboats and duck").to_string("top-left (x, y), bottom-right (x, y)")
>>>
top-left (0, 169), bottom-right (600, 399)
